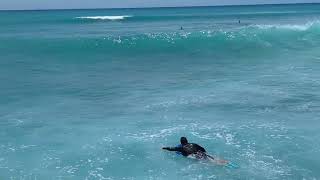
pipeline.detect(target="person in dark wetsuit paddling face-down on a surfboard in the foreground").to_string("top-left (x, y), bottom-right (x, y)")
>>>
top-left (162, 137), bottom-right (207, 159)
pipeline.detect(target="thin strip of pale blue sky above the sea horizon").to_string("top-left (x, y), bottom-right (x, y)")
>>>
top-left (0, 0), bottom-right (320, 10)
